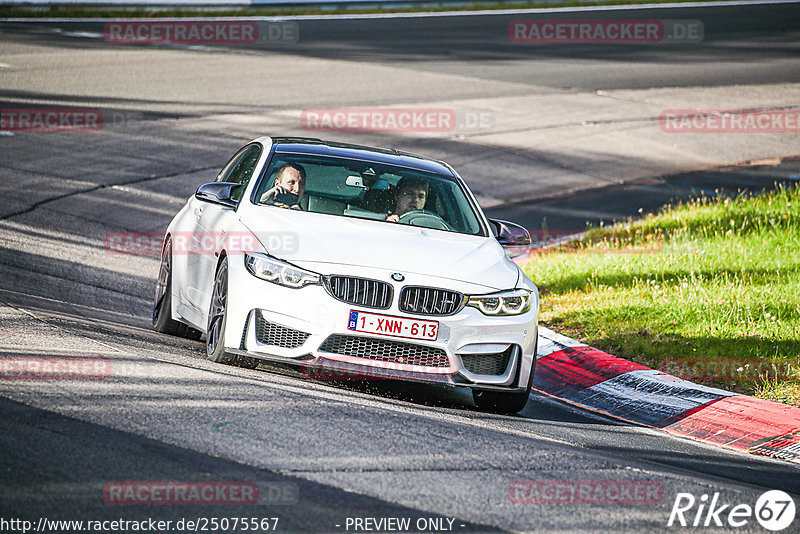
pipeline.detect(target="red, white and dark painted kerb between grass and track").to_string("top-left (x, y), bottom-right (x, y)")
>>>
top-left (533, 326), bottom-right (800, 463)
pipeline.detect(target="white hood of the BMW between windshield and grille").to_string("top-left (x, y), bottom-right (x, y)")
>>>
top-left (240, 206), bottom-right (519, 290)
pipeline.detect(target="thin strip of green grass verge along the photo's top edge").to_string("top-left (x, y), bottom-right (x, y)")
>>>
top-left (0, 0), bottom-right (728, 19)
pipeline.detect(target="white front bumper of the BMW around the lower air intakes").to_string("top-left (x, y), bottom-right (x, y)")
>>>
top-left (225, 258), bottom-right (538, 391)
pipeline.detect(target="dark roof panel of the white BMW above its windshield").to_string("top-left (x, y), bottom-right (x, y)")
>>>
top-left (270, 137), bottom-right (454, 176)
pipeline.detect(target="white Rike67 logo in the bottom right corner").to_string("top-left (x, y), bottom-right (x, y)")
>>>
top-left (667, 490), bottom-right (795, 532)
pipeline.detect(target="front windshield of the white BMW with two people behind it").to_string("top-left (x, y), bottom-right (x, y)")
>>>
top-left (253, 153), bottom-right (484, 235)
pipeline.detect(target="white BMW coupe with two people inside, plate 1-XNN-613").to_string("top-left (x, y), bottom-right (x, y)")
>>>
top-left (153, 137), bottom-right (539, 413)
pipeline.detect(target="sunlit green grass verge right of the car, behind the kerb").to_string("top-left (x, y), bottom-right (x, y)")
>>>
top-left (525, 187), bottom-right (800, 405)
